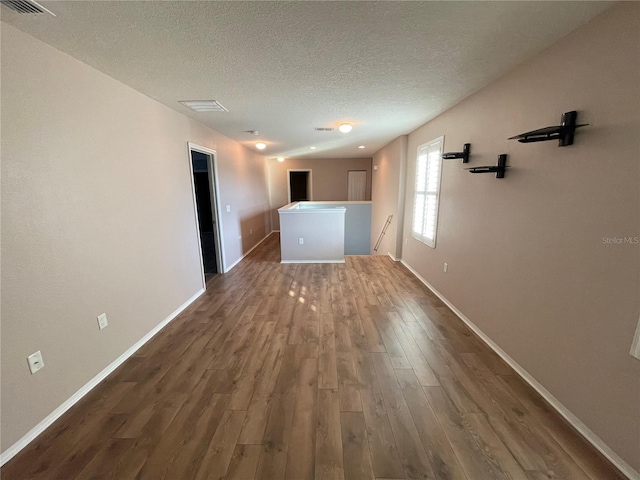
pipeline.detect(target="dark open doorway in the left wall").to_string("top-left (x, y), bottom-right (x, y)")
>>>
top-left (189, 145), bottom-right (224, 285)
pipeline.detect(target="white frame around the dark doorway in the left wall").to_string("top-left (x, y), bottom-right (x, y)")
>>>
top-left (187, 142), bottom-right (226, 289)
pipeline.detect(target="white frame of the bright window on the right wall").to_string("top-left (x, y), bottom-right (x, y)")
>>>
top-left (411, 135), bottom-right (444, 248)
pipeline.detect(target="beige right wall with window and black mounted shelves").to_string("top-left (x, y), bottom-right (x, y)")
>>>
top-left (402, 2), bottom-right (640, 470)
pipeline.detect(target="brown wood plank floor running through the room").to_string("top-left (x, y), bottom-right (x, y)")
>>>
top-left (1, 235), bottom-right (623, 480)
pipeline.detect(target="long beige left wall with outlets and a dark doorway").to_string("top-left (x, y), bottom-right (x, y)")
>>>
top-left (1, 23), bottom-right (270, 451)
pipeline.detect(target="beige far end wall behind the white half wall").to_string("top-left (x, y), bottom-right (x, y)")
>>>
top-left (267, 158), bottom-right (371, 230)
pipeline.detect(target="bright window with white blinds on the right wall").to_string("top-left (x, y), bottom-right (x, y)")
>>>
top-left (412, 137), bottom-right (444, 248)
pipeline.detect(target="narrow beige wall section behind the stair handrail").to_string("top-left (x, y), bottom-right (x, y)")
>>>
top-left (371, 135), bottom-right (407, 259)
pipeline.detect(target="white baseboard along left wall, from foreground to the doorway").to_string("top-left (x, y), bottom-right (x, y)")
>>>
top-left (0, 288), bottom-right (204, 466)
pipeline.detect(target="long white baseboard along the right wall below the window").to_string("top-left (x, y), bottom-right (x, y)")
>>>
top-left (400, 260), bottom-right (640, 480)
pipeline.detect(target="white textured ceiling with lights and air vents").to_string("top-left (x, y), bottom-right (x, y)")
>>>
top-left (2, 1), bottom-right (610, 158)
